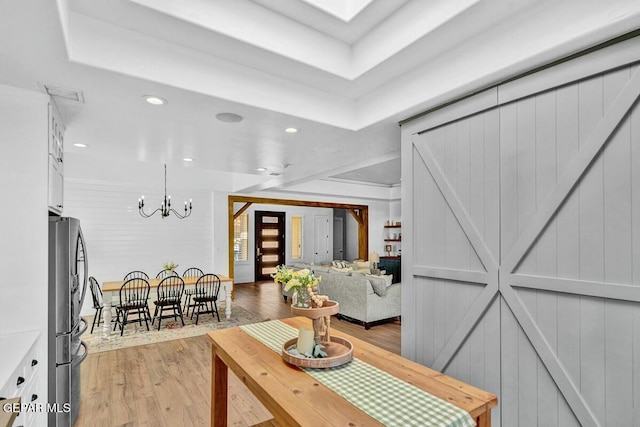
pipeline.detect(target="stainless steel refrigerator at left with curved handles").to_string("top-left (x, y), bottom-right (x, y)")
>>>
top-left (47, 217), bottom-right (88, 427)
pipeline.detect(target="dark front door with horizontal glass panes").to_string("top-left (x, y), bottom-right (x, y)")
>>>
top-left (255, 211), bottom-right (285, 282)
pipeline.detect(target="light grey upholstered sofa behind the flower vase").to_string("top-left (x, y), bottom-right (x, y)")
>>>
top-left (283, 264), bottom-right (402, 329)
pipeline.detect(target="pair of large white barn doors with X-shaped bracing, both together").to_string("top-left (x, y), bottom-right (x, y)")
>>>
top-left (402, 42), bottom-right (640, 427)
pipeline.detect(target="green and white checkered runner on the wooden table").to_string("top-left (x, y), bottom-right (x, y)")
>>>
top-left (240, 320), bottom-right (475, 427)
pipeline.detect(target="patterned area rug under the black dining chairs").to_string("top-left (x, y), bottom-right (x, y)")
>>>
top-left (82, 304), bottom-right (266, 354)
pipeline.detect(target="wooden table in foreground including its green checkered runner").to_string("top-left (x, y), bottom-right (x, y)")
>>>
top-left (207, 317), bottom-right (498, 427)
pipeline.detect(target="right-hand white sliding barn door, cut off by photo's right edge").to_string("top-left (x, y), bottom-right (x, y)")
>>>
top-left (500, 66), bottom-right (640, 427)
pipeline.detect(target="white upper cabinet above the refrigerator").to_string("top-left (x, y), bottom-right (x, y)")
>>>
top-left (48, 102), bottom-right (64, 213)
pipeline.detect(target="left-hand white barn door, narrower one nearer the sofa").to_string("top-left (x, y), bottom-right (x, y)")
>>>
top-left (402, 103), bottom-right (500, 423)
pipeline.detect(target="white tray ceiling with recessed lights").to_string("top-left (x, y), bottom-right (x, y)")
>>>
top-left (0, 0), bottom-right (640, 199)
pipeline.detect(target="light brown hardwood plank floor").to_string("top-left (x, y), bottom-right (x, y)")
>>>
top-left (75, 282), bottom-right (400, 427)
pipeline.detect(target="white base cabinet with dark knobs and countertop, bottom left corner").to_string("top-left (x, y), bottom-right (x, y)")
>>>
top-left (0, 331), bottom-right (42, 427)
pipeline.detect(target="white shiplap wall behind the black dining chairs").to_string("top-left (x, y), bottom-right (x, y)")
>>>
top-left (63, 179), bottom-right (215, 314)
